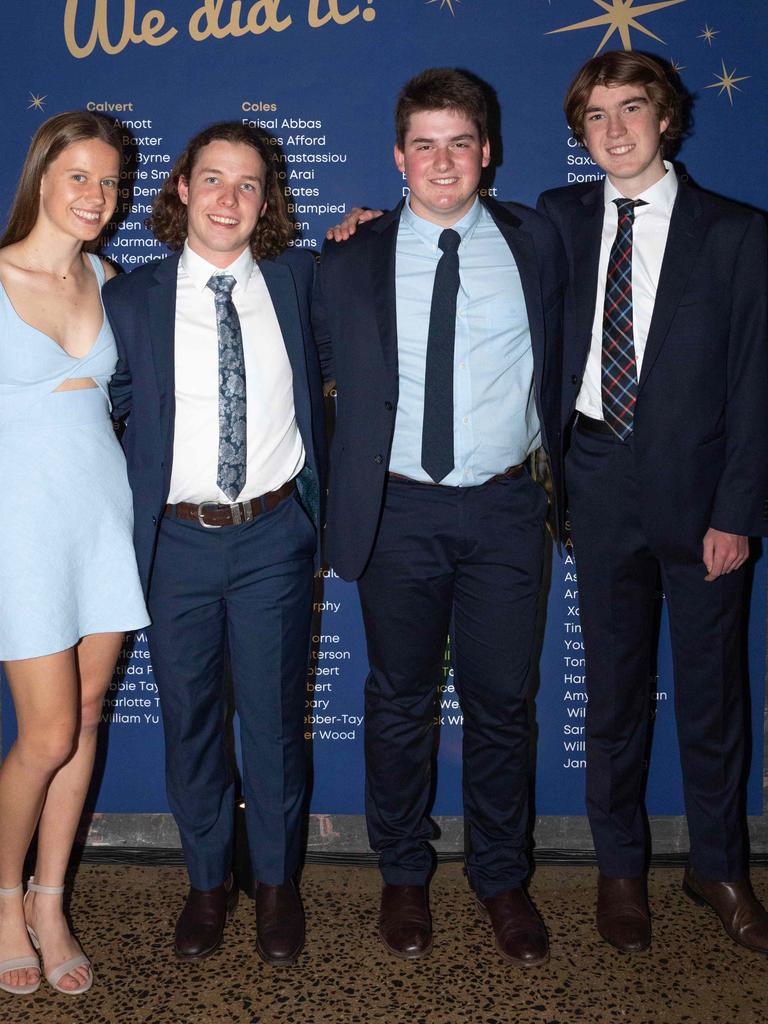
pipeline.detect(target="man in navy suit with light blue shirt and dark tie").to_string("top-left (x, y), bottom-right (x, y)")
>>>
top-left (312, 69), bottom-right (564, 965)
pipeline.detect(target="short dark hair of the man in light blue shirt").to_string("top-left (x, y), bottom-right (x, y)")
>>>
top-left (394, 68), bottom-right (488, 150)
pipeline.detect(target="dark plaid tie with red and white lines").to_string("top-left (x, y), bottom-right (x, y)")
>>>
top-left (602, 199), bottom-right (644, 440)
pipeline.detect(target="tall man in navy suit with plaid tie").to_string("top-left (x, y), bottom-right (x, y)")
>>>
top-left (540, 52), bottom-right (768, 952)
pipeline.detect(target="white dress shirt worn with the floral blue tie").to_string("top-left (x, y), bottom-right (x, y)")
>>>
top-left (168, 245), bottom-right (305, 505)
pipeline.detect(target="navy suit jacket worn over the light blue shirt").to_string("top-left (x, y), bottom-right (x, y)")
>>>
top-left (312, 195), bottom-right (565, 580)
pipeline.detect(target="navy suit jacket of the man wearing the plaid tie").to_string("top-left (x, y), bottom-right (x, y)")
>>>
top-left (539, 180), bottom-right (768, 551)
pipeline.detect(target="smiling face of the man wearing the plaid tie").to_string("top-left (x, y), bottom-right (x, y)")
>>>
top-left (584, 85), bottom-right (669, 199)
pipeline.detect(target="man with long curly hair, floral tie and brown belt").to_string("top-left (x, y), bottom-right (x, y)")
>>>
top-left (104, 122), bottom-right (324, 964)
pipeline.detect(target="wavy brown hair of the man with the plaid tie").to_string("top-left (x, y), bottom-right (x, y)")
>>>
top-left (563, 50), bottom-right (685, 154)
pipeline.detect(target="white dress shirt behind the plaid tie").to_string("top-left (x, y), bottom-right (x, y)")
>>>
top-left (575, 161), bottom-right (677, 420)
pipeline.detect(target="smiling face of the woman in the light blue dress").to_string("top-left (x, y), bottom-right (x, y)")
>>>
top-left (37, 138), bottom-right (120, 242)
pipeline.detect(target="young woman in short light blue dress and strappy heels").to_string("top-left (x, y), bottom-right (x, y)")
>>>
top-left (0, 112), bottom-right (147, 995)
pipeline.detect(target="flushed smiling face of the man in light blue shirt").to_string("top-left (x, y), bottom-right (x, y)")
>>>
top-left (394, 110), bottom-right (490, 227)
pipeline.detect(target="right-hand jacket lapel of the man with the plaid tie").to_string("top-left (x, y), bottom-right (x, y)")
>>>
top-left (638, 181), bottom-right (707, 390)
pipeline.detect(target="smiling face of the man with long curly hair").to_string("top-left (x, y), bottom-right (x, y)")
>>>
top-left (178, 139), bottom-right (266, 267)
